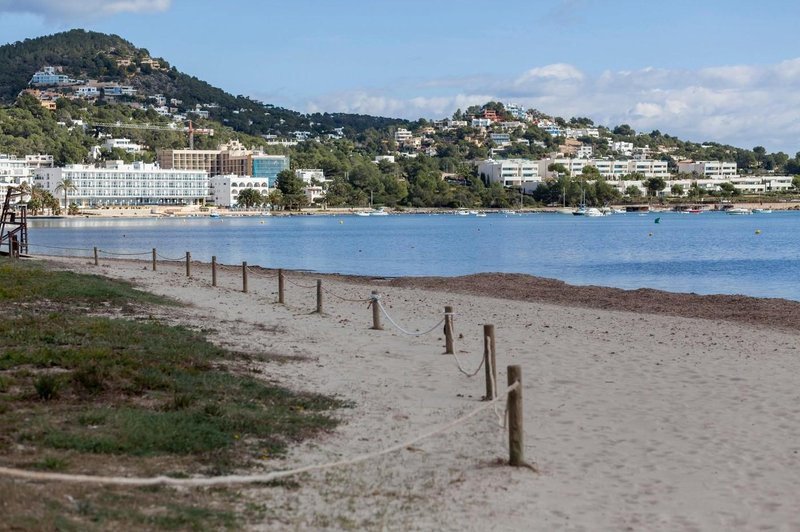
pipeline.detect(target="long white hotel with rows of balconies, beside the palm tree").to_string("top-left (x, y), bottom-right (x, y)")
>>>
top-left (34, 161), bottom-right (208, 207)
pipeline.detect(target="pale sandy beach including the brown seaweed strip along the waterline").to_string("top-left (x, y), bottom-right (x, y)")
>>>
top-left (14, 258), bottom-right (800, 531)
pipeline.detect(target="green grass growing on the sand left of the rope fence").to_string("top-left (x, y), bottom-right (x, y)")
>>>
top-left (0, 261), bottom-right (344, 469)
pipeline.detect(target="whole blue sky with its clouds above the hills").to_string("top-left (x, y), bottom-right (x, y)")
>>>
top-left (0, 0), bottom-right (800, 156)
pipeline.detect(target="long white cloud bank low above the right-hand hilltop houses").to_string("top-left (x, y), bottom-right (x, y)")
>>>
top-left (308, 58), bottom-right (800, 155)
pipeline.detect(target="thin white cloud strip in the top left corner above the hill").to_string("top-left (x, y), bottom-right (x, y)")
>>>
top-left (0, 0), bottom-right (172, 20)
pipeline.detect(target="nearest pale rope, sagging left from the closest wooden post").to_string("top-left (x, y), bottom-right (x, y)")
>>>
top-left (0, 381), bottom-right (520, 487)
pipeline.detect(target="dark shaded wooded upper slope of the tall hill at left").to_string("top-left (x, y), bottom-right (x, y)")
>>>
top-left (0, 30), bottom-right (407, 135)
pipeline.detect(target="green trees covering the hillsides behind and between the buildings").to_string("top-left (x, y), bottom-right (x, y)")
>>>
top-left (0, 30), bottom-right (800, 208)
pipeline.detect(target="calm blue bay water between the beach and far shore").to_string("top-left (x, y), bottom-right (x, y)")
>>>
top-left (29, 212), bottom-right (800, 300)
